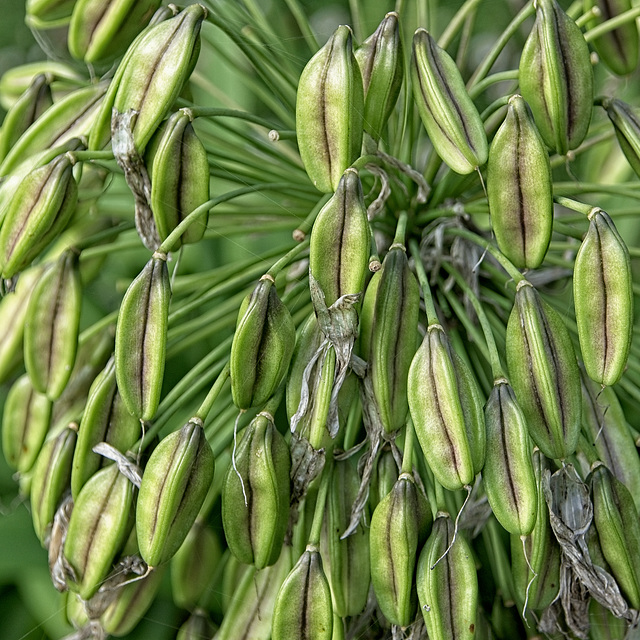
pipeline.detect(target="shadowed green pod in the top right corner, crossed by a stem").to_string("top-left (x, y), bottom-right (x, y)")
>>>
top-left (584, 0), bottom-right (640, 76)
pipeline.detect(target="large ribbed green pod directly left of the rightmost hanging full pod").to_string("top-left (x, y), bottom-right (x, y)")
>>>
top-left (506, 280), bottom-right (581, 459)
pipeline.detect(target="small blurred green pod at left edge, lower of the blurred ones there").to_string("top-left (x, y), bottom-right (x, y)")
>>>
top-left (2, 375), bottom-right (51, 474)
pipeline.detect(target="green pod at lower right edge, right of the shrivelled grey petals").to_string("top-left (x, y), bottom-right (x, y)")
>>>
top-left (590, 463), bottom-right (640, 609)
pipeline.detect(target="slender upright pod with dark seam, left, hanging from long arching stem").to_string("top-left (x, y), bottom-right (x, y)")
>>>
top-left (115, 254), bottom-right (171, 420)
